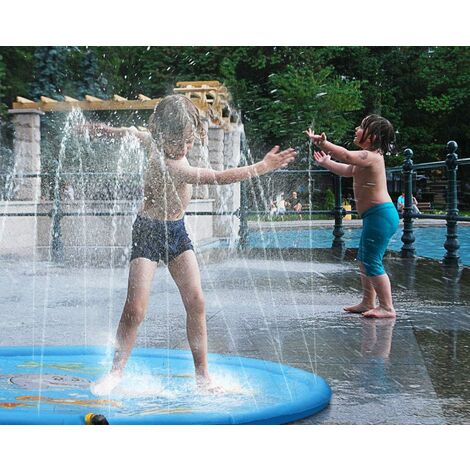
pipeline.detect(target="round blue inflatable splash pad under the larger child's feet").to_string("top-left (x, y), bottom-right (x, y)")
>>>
top-left (0, 346), bottom-right (331, 424)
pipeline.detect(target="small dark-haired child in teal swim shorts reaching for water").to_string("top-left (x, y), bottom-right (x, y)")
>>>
top-left (306, 114), bottom-right (399, 318)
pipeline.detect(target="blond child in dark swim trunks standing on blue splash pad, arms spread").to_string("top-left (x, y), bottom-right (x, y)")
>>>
top-left (88, 95), bottom-right (296, 395)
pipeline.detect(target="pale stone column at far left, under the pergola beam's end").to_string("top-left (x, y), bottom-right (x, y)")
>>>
top-left (8, 109), bottom-right (44, 203)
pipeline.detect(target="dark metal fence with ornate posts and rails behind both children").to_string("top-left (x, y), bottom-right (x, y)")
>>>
top-left (0, 141), bottom-right (470, 265)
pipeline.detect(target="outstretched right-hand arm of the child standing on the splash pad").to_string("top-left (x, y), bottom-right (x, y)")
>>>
top-left (167, 146), bottom-right (296, 184)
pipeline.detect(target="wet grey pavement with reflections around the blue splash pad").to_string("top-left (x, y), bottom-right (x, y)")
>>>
top-left (0, 252), bottom-right (470, 424)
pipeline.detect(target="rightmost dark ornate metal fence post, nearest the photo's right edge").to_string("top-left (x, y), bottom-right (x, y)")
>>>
top-left (443, 140), bottom-right (460, 265)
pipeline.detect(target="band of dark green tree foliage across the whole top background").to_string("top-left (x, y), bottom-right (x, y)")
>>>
top-left (0, 46), bottom-right (470, 162)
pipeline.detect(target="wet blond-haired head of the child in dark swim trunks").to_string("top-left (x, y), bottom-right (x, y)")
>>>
top-left (148, 95), bottom-right (205, 158)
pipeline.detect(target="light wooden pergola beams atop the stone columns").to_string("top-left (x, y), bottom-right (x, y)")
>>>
top-left (13, 80), bottom-right (232, 126)
